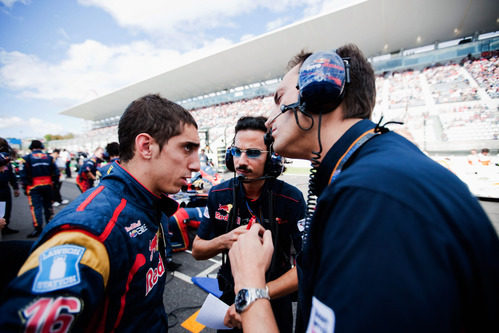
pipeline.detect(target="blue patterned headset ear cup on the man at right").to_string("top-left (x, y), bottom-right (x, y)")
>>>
top-left (281, 51), bottom-right (350, 114)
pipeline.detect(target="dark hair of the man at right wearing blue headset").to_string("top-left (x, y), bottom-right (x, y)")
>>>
top-left (287, 44), bottom-right (376, 119)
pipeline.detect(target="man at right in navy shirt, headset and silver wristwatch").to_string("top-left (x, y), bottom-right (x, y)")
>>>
top-left (229, 45), bottom-right (499, 332)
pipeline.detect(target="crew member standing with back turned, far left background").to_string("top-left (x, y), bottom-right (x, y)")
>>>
top-left (21, 140), bottom-right (59, 238)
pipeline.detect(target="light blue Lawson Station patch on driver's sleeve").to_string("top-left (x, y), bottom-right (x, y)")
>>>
top-left (32, 245), bottom-right (85, 293)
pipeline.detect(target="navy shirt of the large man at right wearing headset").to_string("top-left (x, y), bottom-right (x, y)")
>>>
top-left (298, 120), bottom-right (499, 332)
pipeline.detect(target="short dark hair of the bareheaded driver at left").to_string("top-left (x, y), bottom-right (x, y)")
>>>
top-left (118, 94), bottom-right (198, 162)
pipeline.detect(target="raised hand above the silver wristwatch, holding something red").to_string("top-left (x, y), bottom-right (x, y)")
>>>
top-left (229, 224), bottom-right (274, 294)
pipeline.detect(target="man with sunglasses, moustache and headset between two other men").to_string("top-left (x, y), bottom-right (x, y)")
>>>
top-left (192, 117), bottom-right (305, 332)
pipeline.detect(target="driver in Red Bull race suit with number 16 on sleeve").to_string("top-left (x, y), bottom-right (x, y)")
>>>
top-left (0, 95), bottom-right (199, 333)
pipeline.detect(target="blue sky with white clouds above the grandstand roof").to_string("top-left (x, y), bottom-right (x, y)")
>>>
top-left (0, 0), bottom-right (349, 138)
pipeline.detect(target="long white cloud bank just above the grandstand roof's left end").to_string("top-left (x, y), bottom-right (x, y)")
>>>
top-left (0, 39), bottom-right (231, 104)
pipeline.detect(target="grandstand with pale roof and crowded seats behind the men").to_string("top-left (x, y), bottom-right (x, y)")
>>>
top-left (50, 0), bottom-right (499, 160)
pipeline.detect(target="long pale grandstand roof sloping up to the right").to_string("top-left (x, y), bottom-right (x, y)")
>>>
top-left (61, 0), bottom-right (499, 120)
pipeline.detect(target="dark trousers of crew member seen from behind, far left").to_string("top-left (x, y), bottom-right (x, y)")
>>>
top-left (28, 185), bottom-right (53, 229)
